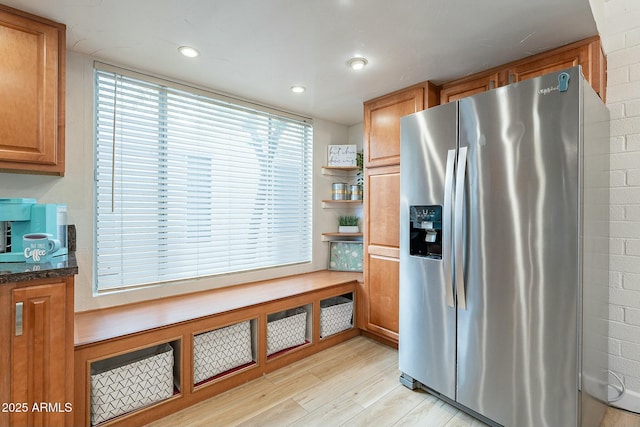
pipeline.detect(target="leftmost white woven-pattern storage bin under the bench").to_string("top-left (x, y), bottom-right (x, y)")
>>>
top-left (91, 344), bottom-right (173, 425)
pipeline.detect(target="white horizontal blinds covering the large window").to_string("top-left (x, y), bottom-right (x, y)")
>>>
top-left (95, 69), bottom-right (312, 290)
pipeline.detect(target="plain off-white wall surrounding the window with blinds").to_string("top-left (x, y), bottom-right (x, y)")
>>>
top-left (0, 52), bottom-right (352, 311)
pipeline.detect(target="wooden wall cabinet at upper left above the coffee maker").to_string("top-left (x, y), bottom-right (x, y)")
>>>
top-left (0, 5), bottom-right (66, 175)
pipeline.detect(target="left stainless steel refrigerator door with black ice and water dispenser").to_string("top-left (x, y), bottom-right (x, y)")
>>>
top-left (398, 103), bottom-right (457, 399)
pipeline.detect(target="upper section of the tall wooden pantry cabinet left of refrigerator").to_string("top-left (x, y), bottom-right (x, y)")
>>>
top-left (364, 82), bottom-right (438, 167)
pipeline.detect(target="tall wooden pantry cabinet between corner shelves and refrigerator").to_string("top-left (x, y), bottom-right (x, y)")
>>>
top-left (357, 82), bottom-right (438, 344)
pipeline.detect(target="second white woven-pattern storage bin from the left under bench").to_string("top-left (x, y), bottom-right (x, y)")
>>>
top-left (193, 320), bottom-right (253, 384)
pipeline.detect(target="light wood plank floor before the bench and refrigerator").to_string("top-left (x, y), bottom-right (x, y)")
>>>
top-left (148, 337), bottom-right (640, 427)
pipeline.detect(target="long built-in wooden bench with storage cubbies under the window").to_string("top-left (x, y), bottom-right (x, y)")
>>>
top-left (74, 270), bottom-right (362, 426)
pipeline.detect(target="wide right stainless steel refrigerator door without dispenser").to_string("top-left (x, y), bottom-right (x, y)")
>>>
top-left (457, 68), bottom-right (581, 427)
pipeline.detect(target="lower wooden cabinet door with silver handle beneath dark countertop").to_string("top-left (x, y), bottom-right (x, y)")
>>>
top-left (10, 282), bottom-right (70, 427)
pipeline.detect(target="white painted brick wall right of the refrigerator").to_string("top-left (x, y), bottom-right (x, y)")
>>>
top-left (590, 0), bottom-right (640, 412)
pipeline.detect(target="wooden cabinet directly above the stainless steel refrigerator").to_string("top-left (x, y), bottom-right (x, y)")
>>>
top-left (440, 36), bottom-right (607, 103)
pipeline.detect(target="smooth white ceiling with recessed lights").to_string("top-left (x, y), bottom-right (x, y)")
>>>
top-left (0, 0), bottom-right (597, 125)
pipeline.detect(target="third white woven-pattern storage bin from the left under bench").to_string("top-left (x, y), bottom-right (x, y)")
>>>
top-left (267, 308), bottom-right (307, 356)
